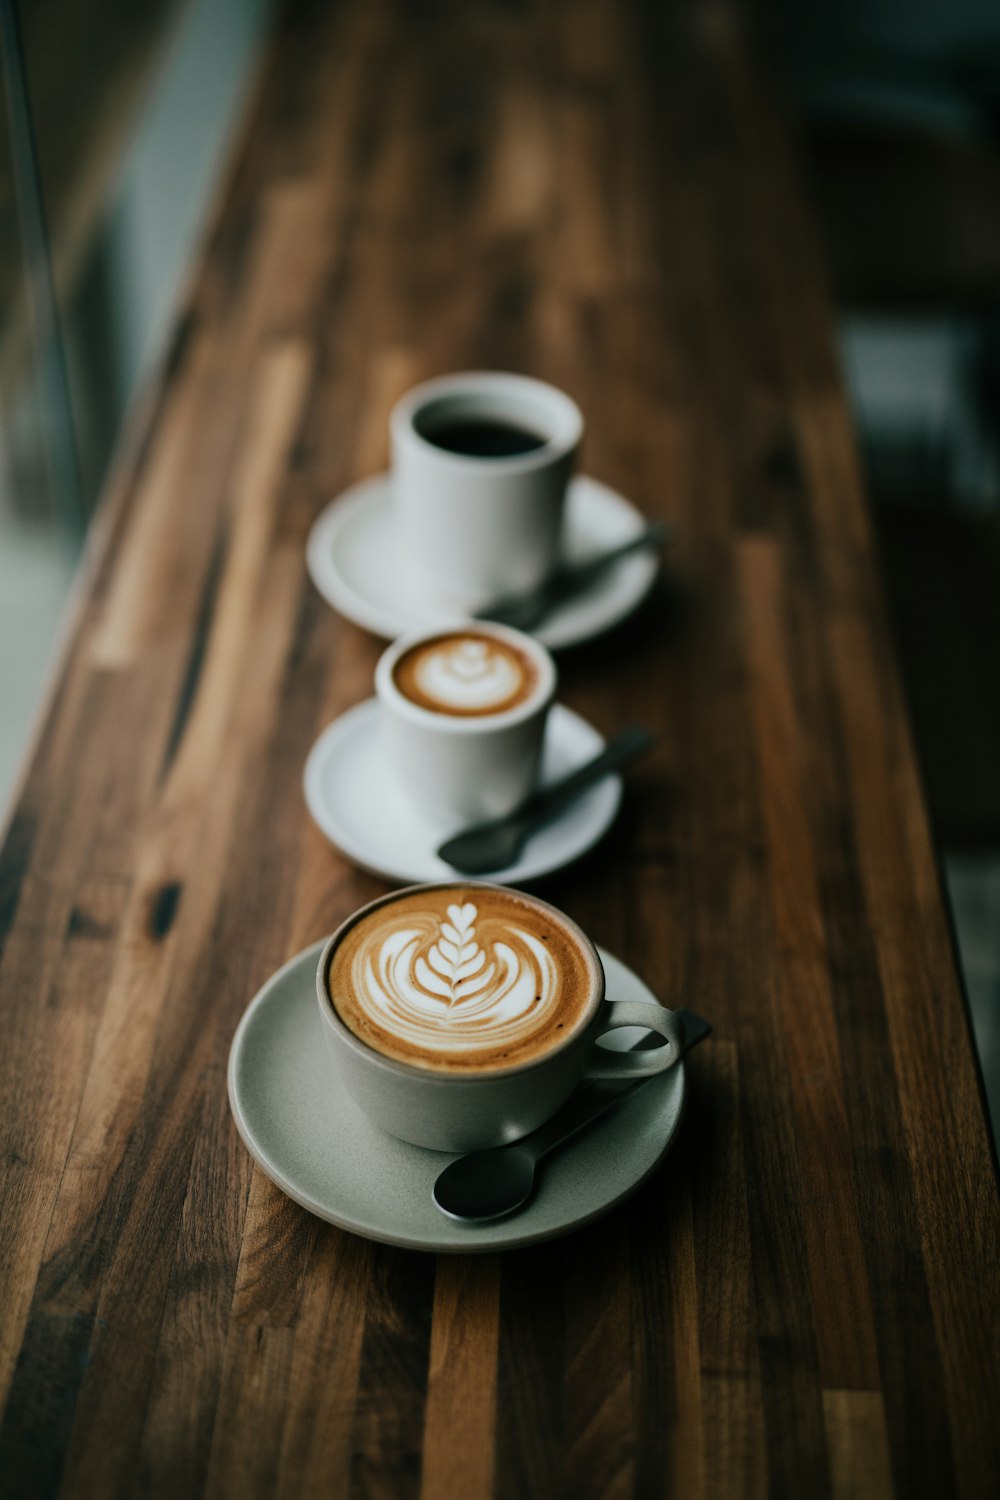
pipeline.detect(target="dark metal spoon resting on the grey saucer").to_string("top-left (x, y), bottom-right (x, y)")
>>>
top-left (433, 1010), bottom-right (712, 1224)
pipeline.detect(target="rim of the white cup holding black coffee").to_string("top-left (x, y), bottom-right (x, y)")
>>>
top-left (388, 371), bottom-right (583, 476)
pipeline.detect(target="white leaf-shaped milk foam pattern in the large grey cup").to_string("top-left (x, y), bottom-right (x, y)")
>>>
top-left (352, 902), bottom-right (559, 1055)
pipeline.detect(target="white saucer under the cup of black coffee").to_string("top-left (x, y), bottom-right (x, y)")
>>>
top-left (306, 474), bottom-right (660, 650)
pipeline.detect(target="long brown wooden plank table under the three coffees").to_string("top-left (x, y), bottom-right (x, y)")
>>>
top-left (0, 0), bottom-right (1000, 1500)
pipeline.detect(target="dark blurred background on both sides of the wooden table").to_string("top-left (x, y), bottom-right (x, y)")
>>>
top-left (0, 0), bottom-right (1000, 1130)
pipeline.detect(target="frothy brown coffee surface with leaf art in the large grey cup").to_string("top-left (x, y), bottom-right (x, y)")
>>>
top-left (327, 885), bottom-right (603, 1073)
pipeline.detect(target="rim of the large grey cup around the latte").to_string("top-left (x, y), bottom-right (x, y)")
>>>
top-left (316, 881), bottom-right (607, 1086)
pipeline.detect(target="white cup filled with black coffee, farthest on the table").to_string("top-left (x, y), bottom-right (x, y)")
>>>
top-left (390, 372), bottom-right (583, 612)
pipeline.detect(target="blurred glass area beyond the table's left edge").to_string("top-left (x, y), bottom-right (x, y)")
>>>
top-left (0, 0), bottom-right (268, 825)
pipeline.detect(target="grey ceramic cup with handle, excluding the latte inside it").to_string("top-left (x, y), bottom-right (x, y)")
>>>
top-left (316, 881), bottom-right (684, 1152)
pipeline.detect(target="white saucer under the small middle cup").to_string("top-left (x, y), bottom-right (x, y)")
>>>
top-left (304, 698), bottom-right (622, 885)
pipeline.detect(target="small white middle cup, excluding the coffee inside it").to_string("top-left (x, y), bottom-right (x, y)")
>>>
top-left (375, 620), bottom-right (556, 824)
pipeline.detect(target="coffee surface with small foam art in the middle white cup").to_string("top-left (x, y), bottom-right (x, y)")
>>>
top-left (393, 630), bottom-right (538, 717)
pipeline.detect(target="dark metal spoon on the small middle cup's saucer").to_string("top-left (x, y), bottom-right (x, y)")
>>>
top-left (438, 728), bottom-right (654, 875)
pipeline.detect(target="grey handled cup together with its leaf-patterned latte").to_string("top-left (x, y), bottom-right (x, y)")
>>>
top-left (316, 881), bottom-right (684, 1152)
